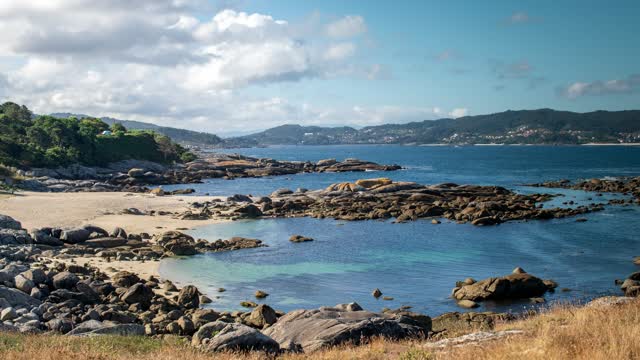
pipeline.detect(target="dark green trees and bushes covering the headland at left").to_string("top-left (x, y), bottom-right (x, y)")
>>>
top-left (0, 102), bottom-right (194, 167)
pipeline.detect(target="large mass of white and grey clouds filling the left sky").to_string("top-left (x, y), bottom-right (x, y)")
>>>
top-left (0, 0), bottom-right (444, 134)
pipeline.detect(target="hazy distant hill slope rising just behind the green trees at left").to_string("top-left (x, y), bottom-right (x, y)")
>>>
top-left (50, 113), bottom-right (223, 146)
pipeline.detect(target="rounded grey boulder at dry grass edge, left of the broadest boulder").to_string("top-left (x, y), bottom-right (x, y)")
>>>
top-left (205, 323), bottom-right (280, 354)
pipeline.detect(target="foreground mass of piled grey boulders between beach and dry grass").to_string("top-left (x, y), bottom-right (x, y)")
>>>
top-left (0, 216), bottom-right (440, 354)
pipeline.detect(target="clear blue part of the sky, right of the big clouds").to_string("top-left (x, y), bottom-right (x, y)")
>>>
top-left (244, 0), bottom-right (640, 114)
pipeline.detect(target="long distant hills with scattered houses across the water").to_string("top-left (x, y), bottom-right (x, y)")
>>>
top-left (224, 109), bottom-right (640, 147)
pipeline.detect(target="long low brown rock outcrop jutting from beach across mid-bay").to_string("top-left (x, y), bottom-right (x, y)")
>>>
top-left (178, 178), bottom-right (603, 226)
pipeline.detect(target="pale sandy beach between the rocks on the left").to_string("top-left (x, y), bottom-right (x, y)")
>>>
top-left (0, 192), bottom-right (222, 234)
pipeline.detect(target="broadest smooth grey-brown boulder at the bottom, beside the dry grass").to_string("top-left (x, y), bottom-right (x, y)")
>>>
top-left (263, 307), bottom-right (431, 352)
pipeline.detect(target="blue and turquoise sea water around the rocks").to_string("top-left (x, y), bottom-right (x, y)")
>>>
top-left (160, 146), bottom-right (640, 315)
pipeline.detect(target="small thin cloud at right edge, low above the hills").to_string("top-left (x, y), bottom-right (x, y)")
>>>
top-left (559, 74), bottom-right (640, 99)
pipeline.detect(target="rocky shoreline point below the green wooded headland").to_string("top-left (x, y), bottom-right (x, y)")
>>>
top-left (11, 153), bottom-right (401, 195)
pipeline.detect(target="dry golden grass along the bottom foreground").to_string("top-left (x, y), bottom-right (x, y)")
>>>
top-left (0, 299), bottom-right (640, 360)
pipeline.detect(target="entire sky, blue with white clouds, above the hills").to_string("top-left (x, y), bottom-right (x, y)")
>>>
top-left (0, 0), bottom-right (640, 136)
